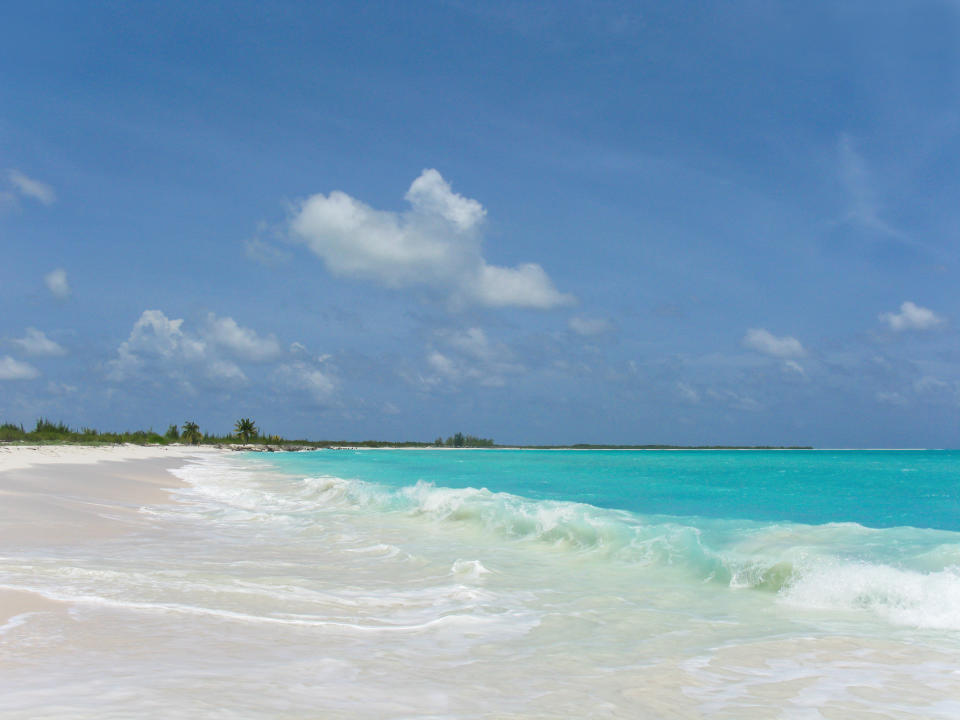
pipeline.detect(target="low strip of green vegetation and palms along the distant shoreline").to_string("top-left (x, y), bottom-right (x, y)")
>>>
top-left (0, 418), bottom-right (812, 450)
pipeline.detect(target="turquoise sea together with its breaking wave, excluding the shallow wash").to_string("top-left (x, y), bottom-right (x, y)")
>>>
top-left (261, 449), bottom-right (960, 631)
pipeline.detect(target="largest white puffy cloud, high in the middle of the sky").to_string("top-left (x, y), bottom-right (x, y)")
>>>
top-left (290, 169), bottom-right (574, 309)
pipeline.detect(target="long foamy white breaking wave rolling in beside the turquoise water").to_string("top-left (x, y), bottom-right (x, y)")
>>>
top-left (167, 456), bottom-right (960, 630)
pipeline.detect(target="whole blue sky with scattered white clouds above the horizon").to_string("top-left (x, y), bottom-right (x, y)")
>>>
top-left (0, 0), bottom-right (960, 447)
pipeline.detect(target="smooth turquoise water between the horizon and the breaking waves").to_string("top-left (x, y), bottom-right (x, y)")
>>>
top-left (270, 450), bottom-right (960, 531)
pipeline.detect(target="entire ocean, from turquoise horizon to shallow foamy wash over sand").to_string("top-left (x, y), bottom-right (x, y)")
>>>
top-left (0, 449), bottom-right (960, 720)
